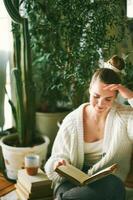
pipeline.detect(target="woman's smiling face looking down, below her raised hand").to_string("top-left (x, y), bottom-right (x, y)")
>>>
top-left (90, 79), bottom-right (116, 114)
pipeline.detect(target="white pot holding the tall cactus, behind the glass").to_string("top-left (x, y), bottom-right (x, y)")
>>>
top-left (1, 135), bottom-right (49, 180)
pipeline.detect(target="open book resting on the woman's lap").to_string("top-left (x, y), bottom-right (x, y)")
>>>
top-left (55, 164), bottom-right (118, 186)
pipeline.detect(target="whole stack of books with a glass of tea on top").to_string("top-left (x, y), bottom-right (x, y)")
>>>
top-left (15, 169), bottom-right (53, 200)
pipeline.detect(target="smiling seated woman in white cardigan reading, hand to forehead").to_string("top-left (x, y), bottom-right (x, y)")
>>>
top-left (45, 55), bottom-right (133, 200)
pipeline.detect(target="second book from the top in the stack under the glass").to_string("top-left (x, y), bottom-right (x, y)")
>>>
top-left (15, 181), bottom-right (53, 199)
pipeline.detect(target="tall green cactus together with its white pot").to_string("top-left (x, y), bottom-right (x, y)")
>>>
top-left (1, 0), bottom-right (49, 179)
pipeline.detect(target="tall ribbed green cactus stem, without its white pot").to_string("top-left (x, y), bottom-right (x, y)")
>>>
top-left (4, 0), bottom-right (35, 146)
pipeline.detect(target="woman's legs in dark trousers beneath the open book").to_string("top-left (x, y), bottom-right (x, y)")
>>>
top-left (54, 175), bottom-right (125, 200)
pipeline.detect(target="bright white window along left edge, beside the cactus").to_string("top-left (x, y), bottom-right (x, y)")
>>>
top-left (0, 0), bottom-right (12, 130)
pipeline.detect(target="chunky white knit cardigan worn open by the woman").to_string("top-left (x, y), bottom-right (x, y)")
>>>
top-left (45, 101), bottom-right (133, 191)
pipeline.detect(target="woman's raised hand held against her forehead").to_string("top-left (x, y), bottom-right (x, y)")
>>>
top-left (104, 84), bottom-right (133, 99)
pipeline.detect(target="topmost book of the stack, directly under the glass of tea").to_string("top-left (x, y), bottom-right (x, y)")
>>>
top-left (17, 169), bottom-right (52, 192)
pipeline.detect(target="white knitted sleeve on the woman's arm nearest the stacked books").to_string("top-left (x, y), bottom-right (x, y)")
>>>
top-left (44, 115), bottom-right (75, 182)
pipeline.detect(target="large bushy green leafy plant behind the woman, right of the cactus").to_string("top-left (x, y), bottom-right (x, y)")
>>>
top-left (25, 0), bottom-right (124, 152)
